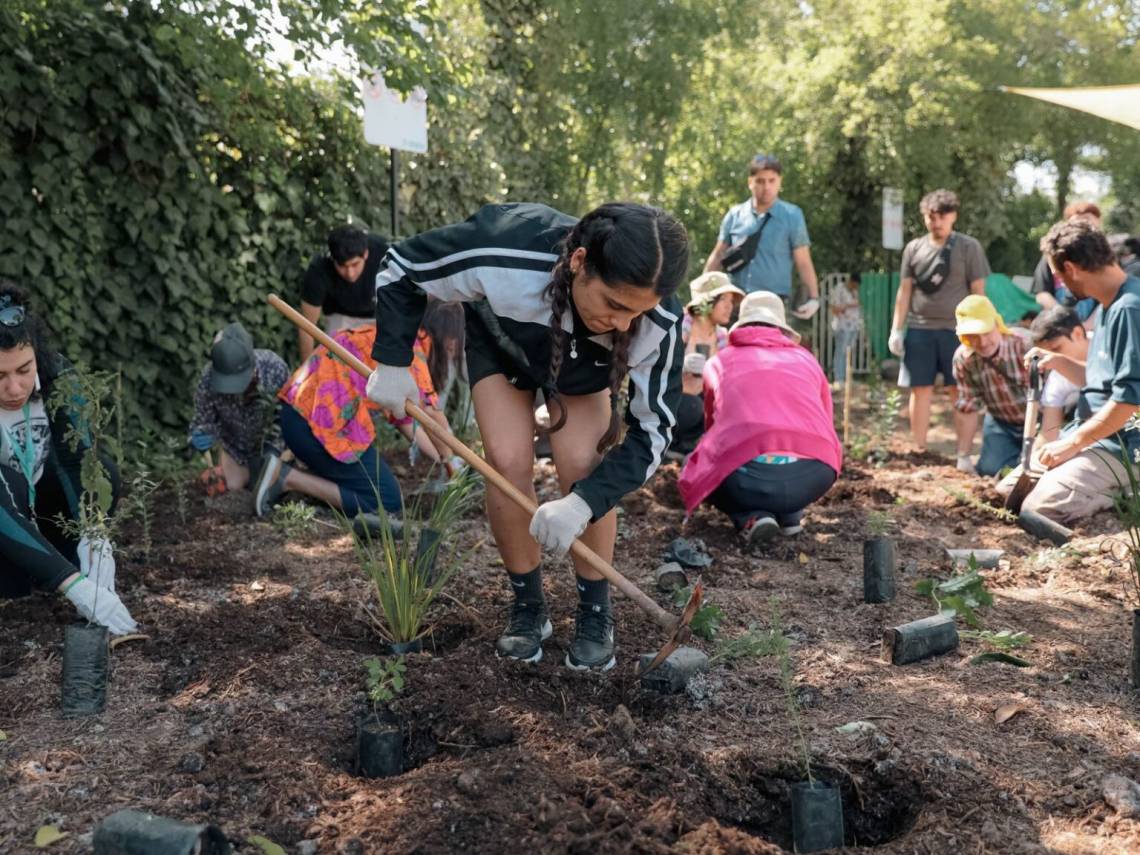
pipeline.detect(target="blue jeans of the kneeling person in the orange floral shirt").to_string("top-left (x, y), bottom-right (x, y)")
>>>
top-left (280, 404), bottom-right (404, 516)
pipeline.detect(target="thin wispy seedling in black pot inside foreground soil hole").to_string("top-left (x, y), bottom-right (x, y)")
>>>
top-left (770, 600), bottom-right (844, 853)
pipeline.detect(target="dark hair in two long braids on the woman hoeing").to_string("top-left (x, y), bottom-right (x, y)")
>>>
top-left (544, 202), bottom-right (689, 454)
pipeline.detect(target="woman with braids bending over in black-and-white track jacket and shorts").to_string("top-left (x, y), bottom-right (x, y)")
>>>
top-left (367, 203), bottom-right (689, 670)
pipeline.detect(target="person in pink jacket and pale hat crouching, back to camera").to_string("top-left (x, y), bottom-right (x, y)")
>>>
top-left (678, 291), bottom-right (842, 544)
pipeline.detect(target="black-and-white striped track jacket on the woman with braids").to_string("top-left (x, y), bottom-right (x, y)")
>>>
top-left (372, 204), bottom-right (684, 520)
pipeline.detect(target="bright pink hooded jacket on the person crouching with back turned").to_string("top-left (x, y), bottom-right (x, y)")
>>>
top-left (677, 326), bottom-right (844, 512)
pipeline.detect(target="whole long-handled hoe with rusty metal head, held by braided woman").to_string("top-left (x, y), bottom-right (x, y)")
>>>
top-left (268, 294), bottom-right (702, 677)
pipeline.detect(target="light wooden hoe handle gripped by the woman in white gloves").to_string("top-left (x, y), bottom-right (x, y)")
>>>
top-left (268, 294), bottom-right (681, 632)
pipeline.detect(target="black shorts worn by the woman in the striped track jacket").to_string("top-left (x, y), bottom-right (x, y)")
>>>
top-left (463, 303), bottom-right (610, 394)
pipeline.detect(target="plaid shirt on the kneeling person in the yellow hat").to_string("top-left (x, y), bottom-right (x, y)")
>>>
top-left (954, 329), bottom-right (1031, 424)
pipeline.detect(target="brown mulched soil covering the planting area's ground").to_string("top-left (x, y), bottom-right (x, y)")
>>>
top-left (0, 399), bottom-right (1140, 855)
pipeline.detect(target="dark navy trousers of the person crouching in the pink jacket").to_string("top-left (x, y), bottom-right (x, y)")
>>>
top-left (709, 459), bottom-right (837, 529)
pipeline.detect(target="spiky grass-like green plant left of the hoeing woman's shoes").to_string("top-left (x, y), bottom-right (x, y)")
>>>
top-left (342, 473), bottom-right (478, 654)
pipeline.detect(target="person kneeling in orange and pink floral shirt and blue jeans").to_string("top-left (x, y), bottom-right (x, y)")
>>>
top-left (255, 324), bottom-right (447, 518)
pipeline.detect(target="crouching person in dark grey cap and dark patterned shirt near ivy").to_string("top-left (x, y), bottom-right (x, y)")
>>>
top-left (189, 323), bottom-right (288, 490)
